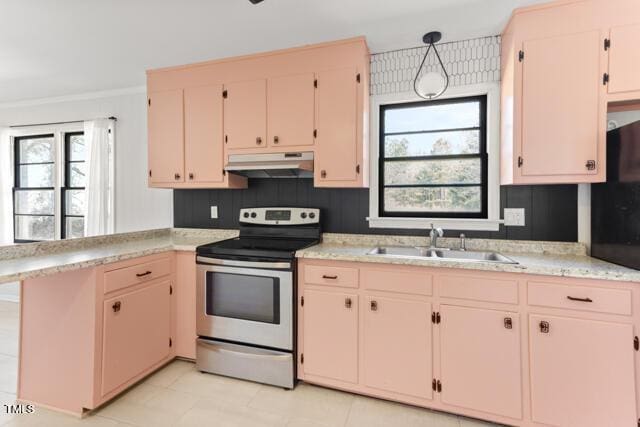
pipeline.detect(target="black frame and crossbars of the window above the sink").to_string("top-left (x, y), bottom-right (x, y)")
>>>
top-left (378, 95), bottom-right (489, 219)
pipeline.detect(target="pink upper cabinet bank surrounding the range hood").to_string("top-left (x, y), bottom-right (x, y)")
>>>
top-left (147, 37), bottom-right (369, 188)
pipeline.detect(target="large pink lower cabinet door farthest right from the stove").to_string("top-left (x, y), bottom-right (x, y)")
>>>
top-left (529, 315), bottom-right (637, 427)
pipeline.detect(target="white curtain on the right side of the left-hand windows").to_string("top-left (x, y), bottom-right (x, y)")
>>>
top-left (84, 119), bottom-right (113, 237)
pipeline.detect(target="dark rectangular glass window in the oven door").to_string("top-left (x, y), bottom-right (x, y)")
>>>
top-left (206, 271), bottom-right (280, 324)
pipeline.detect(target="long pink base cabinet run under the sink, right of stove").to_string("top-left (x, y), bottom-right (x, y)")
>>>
top-left (298, 257), bottom-right (640, 427)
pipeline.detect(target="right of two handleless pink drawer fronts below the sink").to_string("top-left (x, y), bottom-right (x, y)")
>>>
top-left (435, 276), bottom-right (518, 304)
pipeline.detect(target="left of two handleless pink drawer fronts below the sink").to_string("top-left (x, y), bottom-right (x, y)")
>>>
top-left (361, 268), bottom-right (433, 295)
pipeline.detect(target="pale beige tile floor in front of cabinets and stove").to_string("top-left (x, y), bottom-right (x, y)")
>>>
top-left (0, 301), bottom-right (500, 427)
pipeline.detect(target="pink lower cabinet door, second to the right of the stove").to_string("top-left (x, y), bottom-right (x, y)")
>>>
top-left (362, 296), bottom-right (433, 399)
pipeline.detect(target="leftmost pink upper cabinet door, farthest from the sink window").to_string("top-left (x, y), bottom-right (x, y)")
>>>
top-left (148, 90), bottom-right (184, 184)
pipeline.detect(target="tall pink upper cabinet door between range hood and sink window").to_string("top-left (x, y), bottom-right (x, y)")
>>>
top-left (314, 68), bottom-right (358, 187)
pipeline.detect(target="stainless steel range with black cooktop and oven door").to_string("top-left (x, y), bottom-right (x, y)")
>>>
top-left (196, 208), bottom-right (320, 388)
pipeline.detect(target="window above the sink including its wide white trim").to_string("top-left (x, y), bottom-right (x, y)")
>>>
top-left (368, 83), bottom-right (502, 231)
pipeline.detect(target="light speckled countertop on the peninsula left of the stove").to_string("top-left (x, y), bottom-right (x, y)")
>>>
top-left (0, 229), bottom-right (238, 283)
